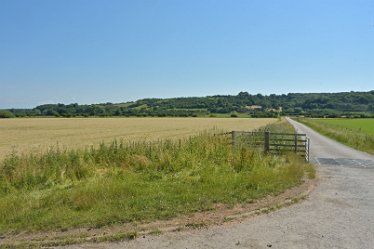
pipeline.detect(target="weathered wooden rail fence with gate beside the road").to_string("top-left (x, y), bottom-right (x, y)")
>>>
top-left (231, 131), bottom-right (310, 162)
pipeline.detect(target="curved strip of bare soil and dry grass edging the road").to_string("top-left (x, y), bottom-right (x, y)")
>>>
top-left (0, 179), bottom-right (316, 248)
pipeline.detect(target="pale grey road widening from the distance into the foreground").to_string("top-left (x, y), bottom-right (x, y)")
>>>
top-left (60, 118), bottom-right (374, 249)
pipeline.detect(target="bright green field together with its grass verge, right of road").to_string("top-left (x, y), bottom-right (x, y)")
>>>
top-left (297, 118), bottom-right (374, 154)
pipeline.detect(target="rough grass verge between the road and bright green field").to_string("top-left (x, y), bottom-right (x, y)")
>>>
top-left (297, 118), bottom-right (374, 154)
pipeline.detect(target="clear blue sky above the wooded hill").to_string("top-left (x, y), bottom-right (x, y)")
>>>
top-left (0, 0), bottom-right (374, 108)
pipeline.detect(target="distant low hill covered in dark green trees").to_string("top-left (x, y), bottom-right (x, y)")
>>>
top-left (3, 90), bottom-right (374, 117)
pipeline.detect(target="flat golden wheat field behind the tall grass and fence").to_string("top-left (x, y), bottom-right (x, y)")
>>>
top-left (0, 118), bottom-right (276, 159)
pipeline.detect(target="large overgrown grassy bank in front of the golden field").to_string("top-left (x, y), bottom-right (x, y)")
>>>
top-left (0, 121), bottom-right (307, 233)
